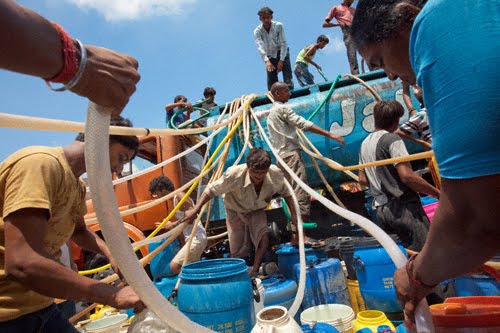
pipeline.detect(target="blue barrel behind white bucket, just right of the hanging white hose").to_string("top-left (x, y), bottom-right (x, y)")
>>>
top-left (294, 258), bottom-right (351, 310)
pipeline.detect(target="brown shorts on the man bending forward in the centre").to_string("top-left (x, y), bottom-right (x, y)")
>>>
top-left (226, 209), bottom-right (267, 258)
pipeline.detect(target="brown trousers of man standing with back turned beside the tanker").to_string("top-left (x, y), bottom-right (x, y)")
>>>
top-left (280, 150), bottom-right (311, 216)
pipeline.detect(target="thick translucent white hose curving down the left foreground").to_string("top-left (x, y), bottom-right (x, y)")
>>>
top-left (85, 102), bottom-right (213, 333)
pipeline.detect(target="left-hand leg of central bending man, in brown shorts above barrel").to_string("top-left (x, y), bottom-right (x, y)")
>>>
top-left (226, 208), bottom-right (250, 259)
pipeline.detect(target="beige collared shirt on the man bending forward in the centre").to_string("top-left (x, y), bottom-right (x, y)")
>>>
top-left (205, 164), bottom-right (290, 213)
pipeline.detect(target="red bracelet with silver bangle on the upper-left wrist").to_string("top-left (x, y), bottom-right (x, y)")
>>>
top-left (45, 23), bottom-right (87, 91)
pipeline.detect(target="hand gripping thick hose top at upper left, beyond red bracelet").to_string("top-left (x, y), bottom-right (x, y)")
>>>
top-left (71, 45), bottom-right (141, 116)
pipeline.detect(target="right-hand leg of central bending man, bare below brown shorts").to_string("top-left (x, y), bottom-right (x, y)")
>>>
top-left (245, 209), bottom-right (269, 276)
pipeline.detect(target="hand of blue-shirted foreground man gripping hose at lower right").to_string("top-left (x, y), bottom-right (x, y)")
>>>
top-left (394, 267), bottom-right (432, 332)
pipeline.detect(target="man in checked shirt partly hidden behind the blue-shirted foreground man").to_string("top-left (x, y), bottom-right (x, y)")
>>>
top-left (396, 85), bottom-right (432, 150)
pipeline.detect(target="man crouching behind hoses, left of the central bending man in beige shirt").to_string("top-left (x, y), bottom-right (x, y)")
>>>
top-left (149, 176), bottom-right (207, 275)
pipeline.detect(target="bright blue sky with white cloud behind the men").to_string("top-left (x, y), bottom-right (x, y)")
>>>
top-left (0, 0), bottom-right (355, 160)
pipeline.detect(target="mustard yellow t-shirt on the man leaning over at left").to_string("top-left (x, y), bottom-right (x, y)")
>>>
top-left (0, 147), bottom-right (86, 322)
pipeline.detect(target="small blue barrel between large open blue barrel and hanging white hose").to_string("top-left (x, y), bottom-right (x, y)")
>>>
top-left (262, 274), bottom-right (297, 310)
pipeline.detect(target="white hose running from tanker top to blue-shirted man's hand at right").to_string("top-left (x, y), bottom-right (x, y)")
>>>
top-left (251, 107), bottom-right (434, 333)
